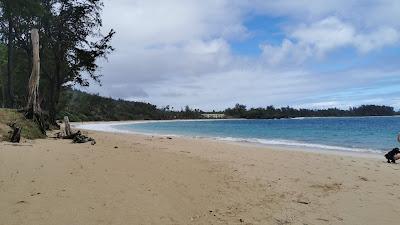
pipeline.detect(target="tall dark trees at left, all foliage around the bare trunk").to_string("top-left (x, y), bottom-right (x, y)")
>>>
top-left (0, 0), bottom-right (115, 122)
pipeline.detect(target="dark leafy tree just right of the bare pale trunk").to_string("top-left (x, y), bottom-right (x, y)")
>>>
top-left (41, 0), bottom-right (115, 123)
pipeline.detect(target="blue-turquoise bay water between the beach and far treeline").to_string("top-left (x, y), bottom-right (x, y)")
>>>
top-left (113, 117), bottom-right (400, 152)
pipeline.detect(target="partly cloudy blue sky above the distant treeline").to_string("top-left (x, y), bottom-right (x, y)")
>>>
top-left (84, 0), bottom-right (400, 110)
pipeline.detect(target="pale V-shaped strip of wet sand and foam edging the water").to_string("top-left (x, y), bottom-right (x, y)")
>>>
top-left (71, 119), bottom-right (384, 159)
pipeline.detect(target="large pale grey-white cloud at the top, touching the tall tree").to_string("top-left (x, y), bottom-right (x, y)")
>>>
top-left (104, 0), bottom-right (247, 46)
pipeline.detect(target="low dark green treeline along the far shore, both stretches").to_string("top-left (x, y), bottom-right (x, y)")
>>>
top-left (57, 89), bottom-right (396, 121)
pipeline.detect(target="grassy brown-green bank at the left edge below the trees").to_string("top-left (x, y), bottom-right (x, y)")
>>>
top-left (0, 108), bottom-right (45, 140)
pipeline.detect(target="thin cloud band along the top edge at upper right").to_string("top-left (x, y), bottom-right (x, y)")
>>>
top-left (247, 0), bottom-right (400, 28)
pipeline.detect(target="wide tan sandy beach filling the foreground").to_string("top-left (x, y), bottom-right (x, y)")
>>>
top-left (0, 131), bottom-right (400, 225)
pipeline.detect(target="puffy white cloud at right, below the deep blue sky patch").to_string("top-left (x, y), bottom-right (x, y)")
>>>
top-left (261, 17), bottom-right (400, 65)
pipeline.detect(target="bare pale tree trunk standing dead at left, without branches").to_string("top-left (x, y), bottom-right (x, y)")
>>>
top-left (25, 29), bottom-right (46, 133)
